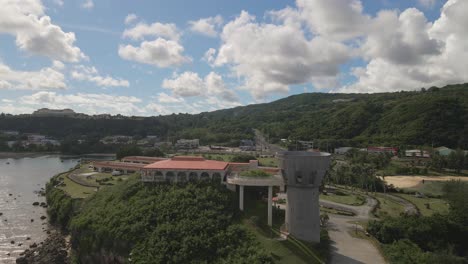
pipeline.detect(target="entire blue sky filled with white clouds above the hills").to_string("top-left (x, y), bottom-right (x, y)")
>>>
top-left (0, 0), bottom-right (468, 116)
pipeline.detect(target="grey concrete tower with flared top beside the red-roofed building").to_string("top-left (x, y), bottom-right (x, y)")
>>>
top-left (277, 151), bottom-right (330, 242)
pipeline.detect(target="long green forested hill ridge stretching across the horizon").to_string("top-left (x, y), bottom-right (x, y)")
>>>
top-left (0, 84), bottom-right (468, 149)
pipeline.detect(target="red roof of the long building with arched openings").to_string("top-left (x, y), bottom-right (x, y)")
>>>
top-left (144, 156), bottom-right (229, 170)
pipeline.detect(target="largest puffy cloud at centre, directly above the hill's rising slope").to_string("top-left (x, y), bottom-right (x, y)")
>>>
top-left (215, 11), bottom-right (351, 100)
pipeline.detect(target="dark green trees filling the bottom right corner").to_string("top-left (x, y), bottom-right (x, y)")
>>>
top-left (368, 181), bottom-right (468, 264)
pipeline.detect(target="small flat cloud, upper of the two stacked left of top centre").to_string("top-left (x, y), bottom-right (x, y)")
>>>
top-left (122, 22), bottom-right (180, 41)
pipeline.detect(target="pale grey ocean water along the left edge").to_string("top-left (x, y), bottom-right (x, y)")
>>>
top-left (0, 156), bottom-right (78, 264)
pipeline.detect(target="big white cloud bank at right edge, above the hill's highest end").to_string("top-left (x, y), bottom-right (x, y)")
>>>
top-left (337, 0), bottom-right (468, 92)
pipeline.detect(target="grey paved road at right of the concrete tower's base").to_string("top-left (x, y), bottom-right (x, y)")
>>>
top-left (320, 197), bottom-right (385, 264)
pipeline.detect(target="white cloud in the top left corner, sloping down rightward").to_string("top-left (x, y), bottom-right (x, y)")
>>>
top-left (0, 0), bottom-right (86, 62)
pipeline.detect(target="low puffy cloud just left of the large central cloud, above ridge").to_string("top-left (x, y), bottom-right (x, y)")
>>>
top-left (162, 72), bottom-right (239, 102)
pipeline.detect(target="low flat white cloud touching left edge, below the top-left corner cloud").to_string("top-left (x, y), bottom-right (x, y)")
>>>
top-left (0, 61), bottom-right (67, 90)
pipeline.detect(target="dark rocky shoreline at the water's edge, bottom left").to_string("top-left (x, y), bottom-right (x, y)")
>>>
top-left (16, 231), bottom-right (70, 264)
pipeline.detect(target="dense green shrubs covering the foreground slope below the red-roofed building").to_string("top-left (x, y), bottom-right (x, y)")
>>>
top-left (48, 175), bottom-right (273, 263)
